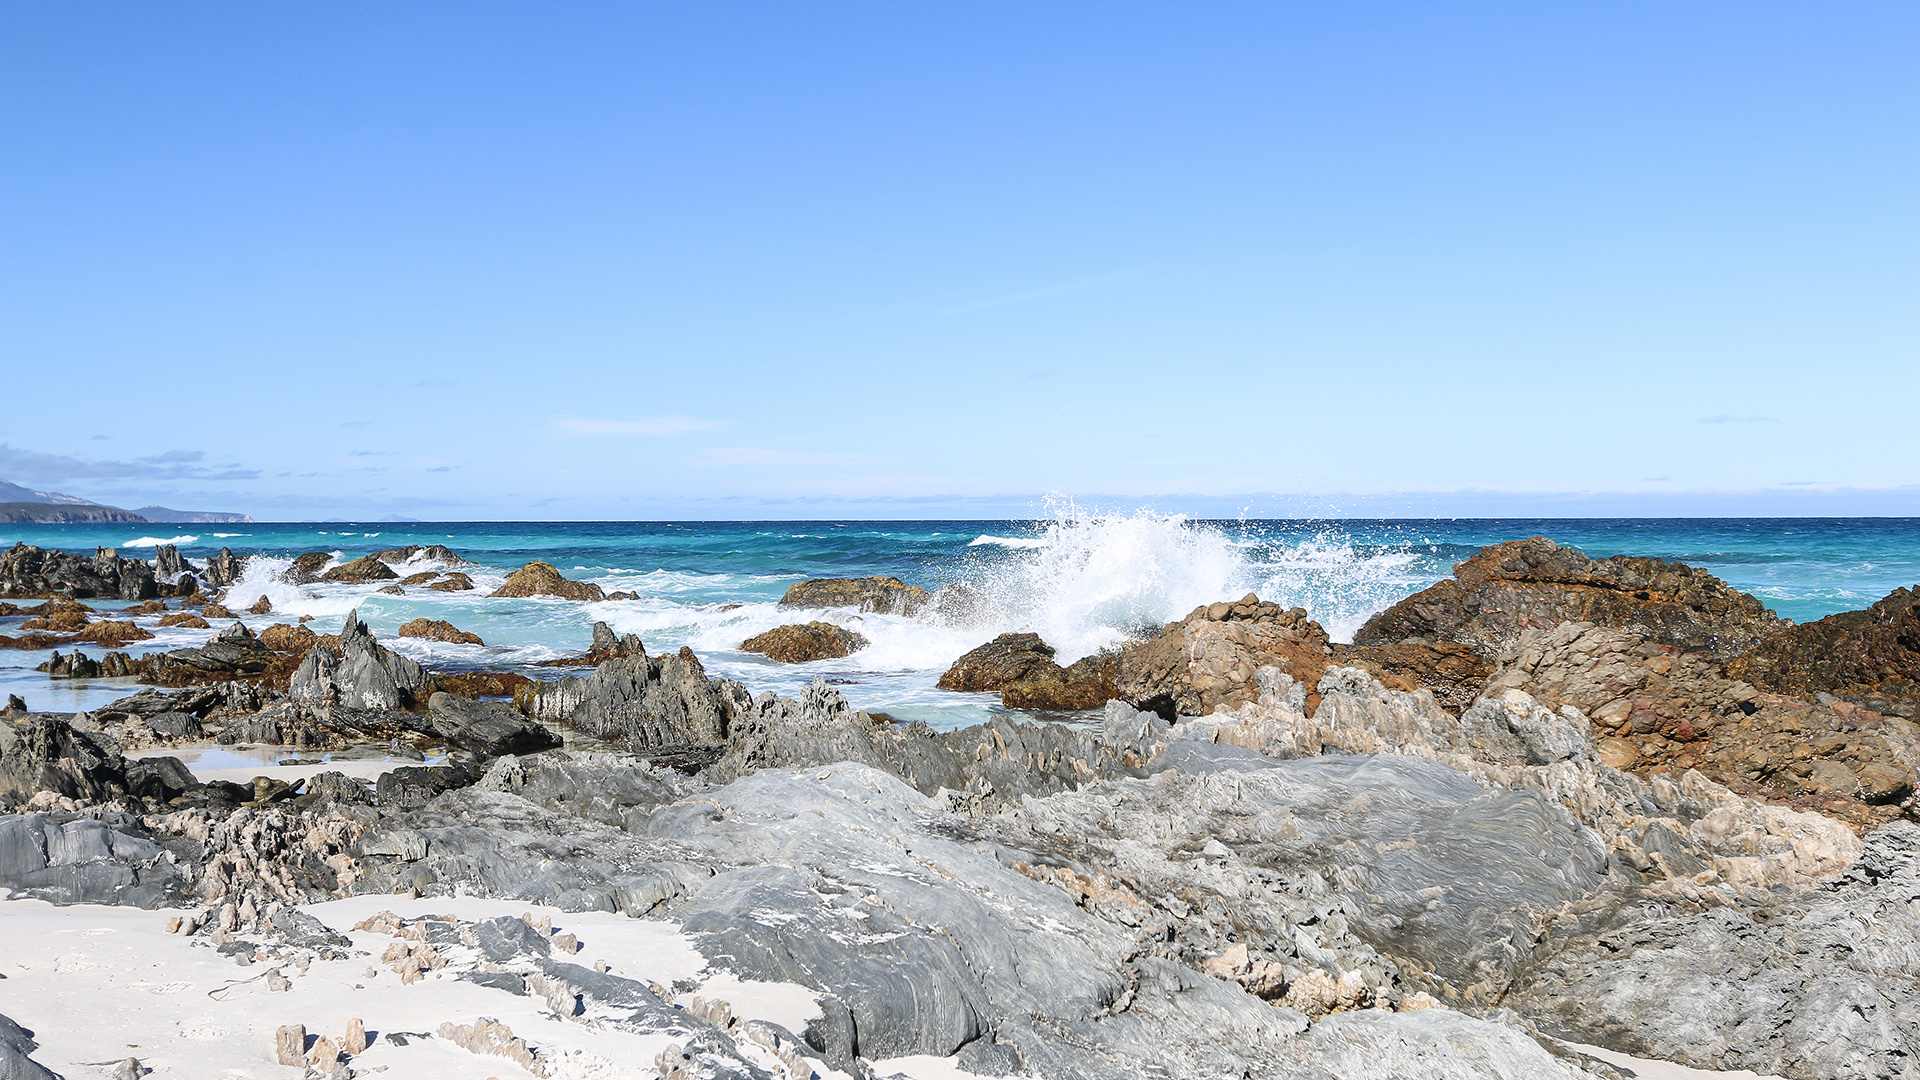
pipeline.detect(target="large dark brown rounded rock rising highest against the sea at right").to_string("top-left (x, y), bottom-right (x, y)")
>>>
top-left (1354, 536), bottom-right (1782, 659)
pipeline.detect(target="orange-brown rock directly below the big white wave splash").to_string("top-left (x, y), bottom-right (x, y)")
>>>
top-left (1116, 594), bottom-right (1332, 719)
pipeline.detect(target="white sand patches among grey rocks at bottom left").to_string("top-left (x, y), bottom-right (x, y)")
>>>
top-left (0, 896), bottom-right (856, 1080)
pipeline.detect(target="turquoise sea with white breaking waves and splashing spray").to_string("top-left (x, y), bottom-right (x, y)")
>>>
top-left (0, 513), bottom-right (1920, 726)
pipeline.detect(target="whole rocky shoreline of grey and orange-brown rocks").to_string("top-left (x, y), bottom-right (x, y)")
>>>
top-left (0, 538), bottom-right (1920, 1080)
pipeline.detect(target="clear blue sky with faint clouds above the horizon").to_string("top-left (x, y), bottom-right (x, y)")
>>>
top-left (0, 2), bottom-right (1920, 519)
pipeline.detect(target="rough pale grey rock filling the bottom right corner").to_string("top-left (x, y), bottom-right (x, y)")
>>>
top-left (1507, 821), bottom-right (1920, 1080)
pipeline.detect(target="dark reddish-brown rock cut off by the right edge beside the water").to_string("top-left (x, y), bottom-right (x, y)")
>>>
top-left (1728, 588), bottom-right (1920, 721)
